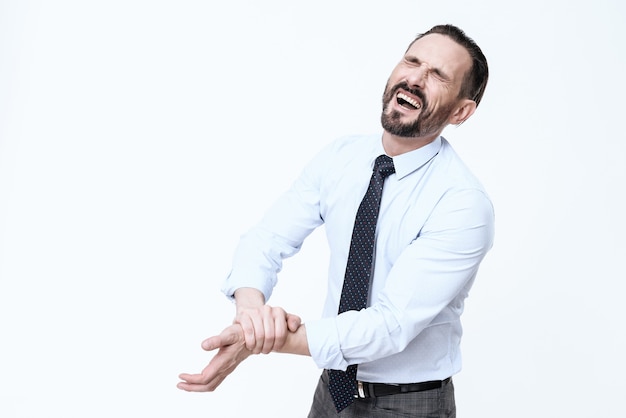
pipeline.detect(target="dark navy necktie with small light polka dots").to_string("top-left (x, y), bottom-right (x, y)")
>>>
top-left (328, 155), bottom-right (395, 412)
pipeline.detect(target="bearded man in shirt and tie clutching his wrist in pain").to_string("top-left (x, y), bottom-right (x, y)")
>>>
top-left (178, 25), bottom-right (494, 417)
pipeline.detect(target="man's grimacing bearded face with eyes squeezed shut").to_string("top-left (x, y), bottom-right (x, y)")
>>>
top-left (381, 34), bottom-right (472, 137)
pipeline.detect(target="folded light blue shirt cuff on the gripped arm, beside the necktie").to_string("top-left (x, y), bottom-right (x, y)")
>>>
top-left (306, 318), bottom-right (348, 370)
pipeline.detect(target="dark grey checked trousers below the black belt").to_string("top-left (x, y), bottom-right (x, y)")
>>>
top-left (308, 371), bottom-right (456, 418)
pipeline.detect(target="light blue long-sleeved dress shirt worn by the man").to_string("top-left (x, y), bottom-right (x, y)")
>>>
top-left (222, 134), bottom-right (494, 383)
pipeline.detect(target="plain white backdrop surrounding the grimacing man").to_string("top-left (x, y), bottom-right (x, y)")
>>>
top-left (0, 0), bottom-right (626, 418)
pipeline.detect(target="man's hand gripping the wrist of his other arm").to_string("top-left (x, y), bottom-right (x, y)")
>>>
top-left (234, 287), bottom-right (302, 354)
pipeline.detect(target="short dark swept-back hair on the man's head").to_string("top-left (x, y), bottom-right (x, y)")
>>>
top-left (409, 25), bottom-right (489, 106)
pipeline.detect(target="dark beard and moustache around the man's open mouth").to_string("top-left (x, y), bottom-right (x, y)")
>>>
top-left (380, 79), bottom-right (454, 138)
